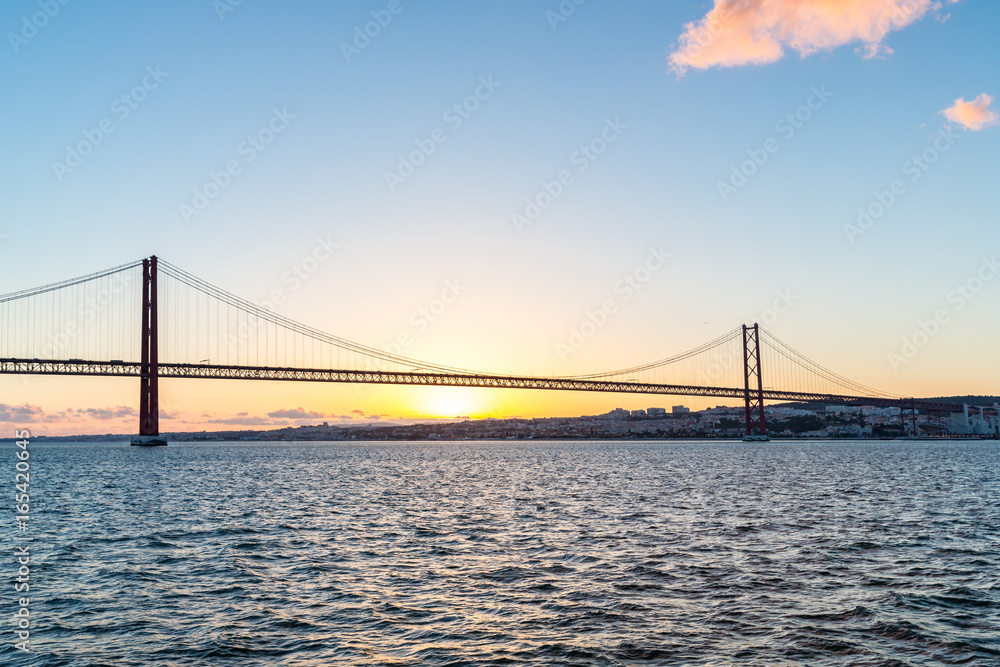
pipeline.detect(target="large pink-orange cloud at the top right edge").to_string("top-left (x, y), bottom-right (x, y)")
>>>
top-left (668, 0), bottom-right (958, 76)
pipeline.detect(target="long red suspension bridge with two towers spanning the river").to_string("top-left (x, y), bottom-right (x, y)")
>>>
top-left (0, 256), bottom-right (988, 444)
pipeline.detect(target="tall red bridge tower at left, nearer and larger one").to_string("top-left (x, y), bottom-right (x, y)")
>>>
top-left (132, 255), bottom-right (167, 447)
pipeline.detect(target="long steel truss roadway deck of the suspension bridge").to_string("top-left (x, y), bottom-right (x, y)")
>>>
top-left (0, 359), bottom-right (963, 412)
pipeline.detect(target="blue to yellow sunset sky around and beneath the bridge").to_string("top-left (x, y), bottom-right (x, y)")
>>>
top-left (0, 0), bottom-right (1000, 434)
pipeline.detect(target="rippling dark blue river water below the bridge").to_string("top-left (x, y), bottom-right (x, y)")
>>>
top-left (7, 442), bottom-right (1000, 666)
